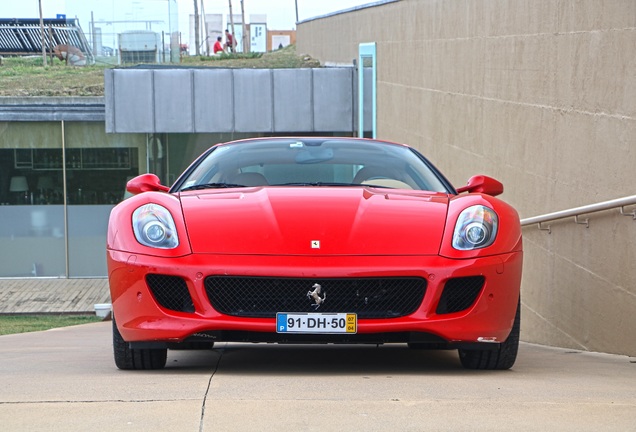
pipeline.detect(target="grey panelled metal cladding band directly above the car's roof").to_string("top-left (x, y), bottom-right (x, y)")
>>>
top-left (106, 67), bottom-right (357, 133)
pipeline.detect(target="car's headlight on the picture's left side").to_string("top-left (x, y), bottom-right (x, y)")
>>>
top-left (132, 204), bottom-right (179, 249)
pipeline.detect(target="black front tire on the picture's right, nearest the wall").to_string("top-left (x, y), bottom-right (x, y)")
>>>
top-left (459, 301), bottom-right (521, 370)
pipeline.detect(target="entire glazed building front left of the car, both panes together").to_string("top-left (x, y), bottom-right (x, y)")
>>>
top-left (0, 122), bottom-right (146, 277)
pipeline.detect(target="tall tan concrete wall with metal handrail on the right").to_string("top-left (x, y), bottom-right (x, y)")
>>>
top-left (297, 0), bottom-right (636, 356)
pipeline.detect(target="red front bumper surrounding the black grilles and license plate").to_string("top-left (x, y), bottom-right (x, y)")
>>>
top-left (108, 250), bottom-right (522, 346)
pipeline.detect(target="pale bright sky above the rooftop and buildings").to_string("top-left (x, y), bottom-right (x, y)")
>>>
top-left (0, 0), bottom-right (374, 34)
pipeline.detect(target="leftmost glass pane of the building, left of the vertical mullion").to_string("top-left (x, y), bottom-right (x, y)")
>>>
top-left (0, 122), bottom-right (66, 277)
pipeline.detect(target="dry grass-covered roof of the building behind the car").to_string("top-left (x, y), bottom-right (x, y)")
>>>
top-left (0, 45), bottom-right (320, 96)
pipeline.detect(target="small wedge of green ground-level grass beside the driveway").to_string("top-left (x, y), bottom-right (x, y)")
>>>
top-left (0, 315), bottom-right (103, 335)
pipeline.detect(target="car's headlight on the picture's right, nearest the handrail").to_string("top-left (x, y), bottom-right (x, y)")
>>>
top-left (453, 205), bottom-right (499, 250)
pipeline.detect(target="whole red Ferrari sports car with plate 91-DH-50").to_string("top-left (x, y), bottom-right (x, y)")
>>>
top-left (107, 138), bottom-right (522, 369)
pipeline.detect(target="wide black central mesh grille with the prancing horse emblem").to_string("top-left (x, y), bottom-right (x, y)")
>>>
top-left (205, 276), bottom-right (426, 318)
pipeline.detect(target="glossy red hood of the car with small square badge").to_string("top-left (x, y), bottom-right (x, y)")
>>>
top-left (180, 187), bottom-right (448, 255)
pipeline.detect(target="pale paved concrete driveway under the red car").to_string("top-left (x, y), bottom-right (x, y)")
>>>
top-left (0, 322), bottom-right (636, 432)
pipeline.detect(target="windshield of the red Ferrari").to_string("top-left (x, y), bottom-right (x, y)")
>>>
top-left (173, 138), bottom-right (450, 193)
